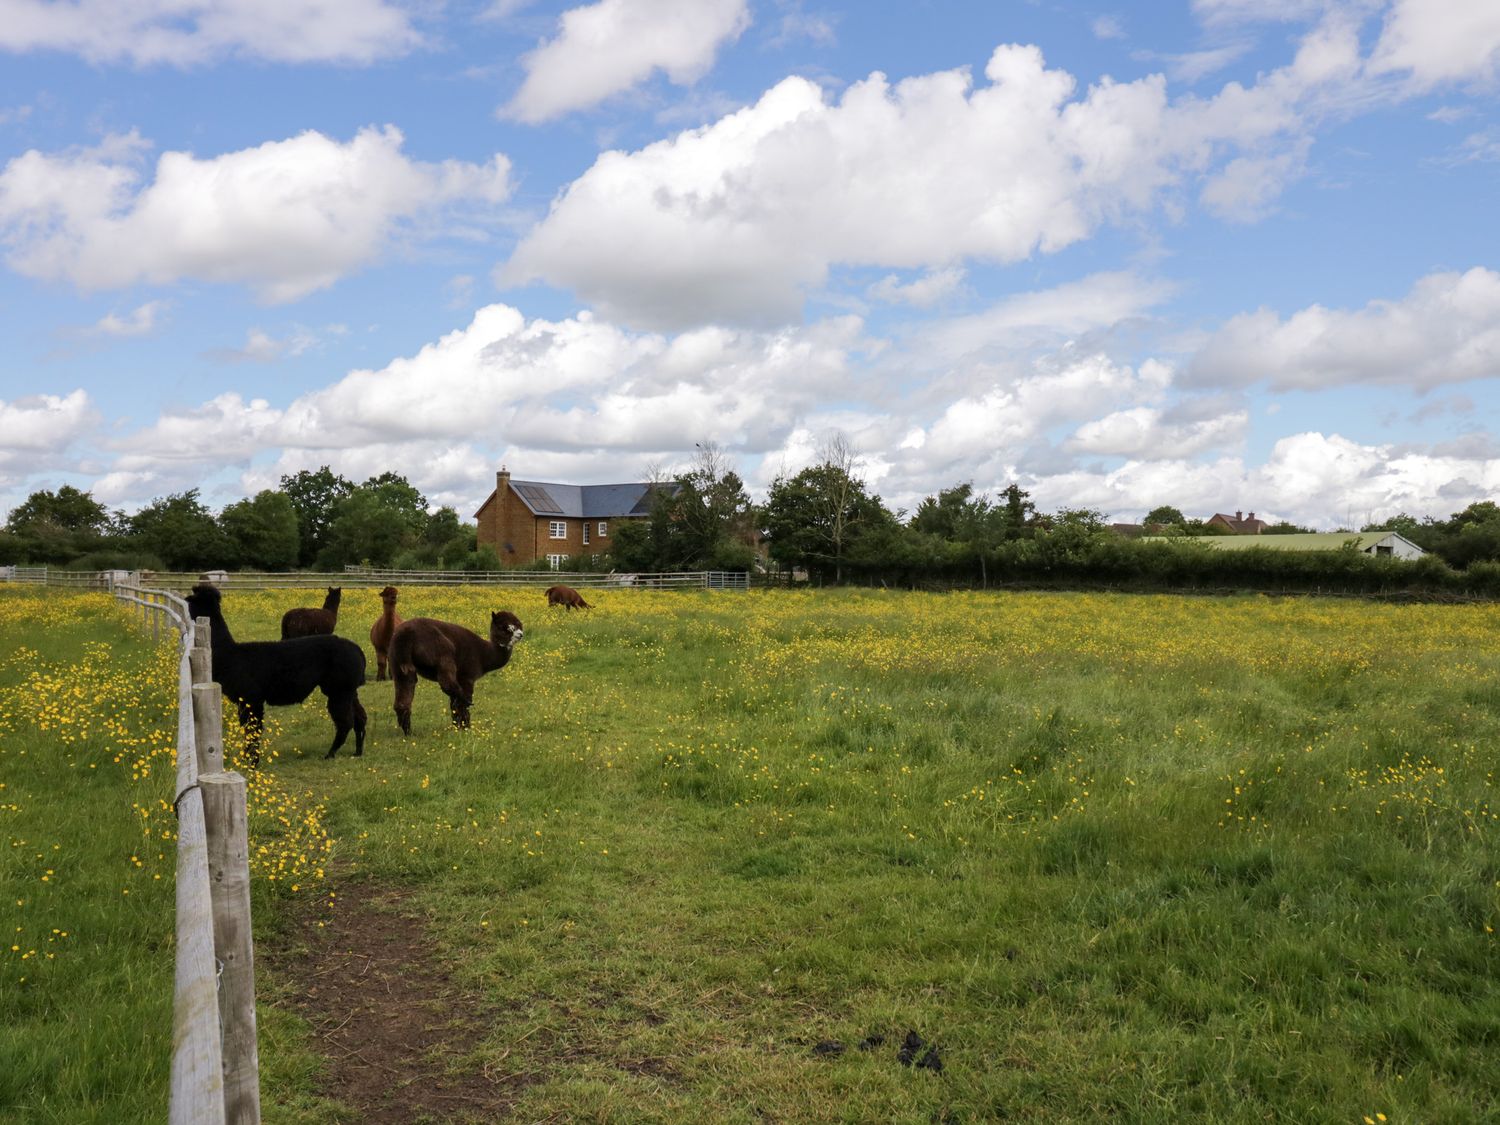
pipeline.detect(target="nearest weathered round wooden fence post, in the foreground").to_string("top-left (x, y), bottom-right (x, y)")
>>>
top-left (194, 774), bottom-right (261, 1125)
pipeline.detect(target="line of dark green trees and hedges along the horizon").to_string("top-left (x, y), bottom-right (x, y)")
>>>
top-left (0, 447), bottom-right (1500, 593)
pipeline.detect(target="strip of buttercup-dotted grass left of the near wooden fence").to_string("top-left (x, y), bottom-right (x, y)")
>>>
top-left (0, 591), bottom-right (177, 1125)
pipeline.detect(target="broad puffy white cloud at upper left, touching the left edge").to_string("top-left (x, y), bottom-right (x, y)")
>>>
top-left (0, 126), bottom-right (510, 302)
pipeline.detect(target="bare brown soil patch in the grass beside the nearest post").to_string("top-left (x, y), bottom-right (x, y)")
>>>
top-left (267, 885), bottom-right (536, 1125)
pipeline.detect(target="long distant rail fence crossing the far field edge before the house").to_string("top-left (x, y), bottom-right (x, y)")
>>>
top-left (0, 567), bottom-right (750, 591)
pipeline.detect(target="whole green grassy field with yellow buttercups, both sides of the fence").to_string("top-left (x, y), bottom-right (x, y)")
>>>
top-left (0, 590), bottom-right (1500, 1122)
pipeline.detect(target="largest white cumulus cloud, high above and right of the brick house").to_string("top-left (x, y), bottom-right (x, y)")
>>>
top-left (500, 34), bottom-right (1359, 327)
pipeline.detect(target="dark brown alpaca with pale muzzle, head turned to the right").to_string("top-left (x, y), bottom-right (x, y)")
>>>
top-left (390, 611), bottom-right (524, 735)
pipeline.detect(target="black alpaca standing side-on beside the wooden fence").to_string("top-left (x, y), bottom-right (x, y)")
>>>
top-left (188, 585), bottom-right (365, 765)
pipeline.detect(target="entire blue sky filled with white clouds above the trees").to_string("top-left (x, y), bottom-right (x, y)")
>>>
top-left (0, 0), bottom-right (1500, 528)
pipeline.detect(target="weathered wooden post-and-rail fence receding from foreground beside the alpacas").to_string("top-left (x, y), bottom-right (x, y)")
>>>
top-left (113, 584), bottom-right (261, 1125)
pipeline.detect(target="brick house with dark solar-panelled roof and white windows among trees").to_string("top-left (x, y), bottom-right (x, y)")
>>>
top-left (474, 468), bottom-right (659, 569)
